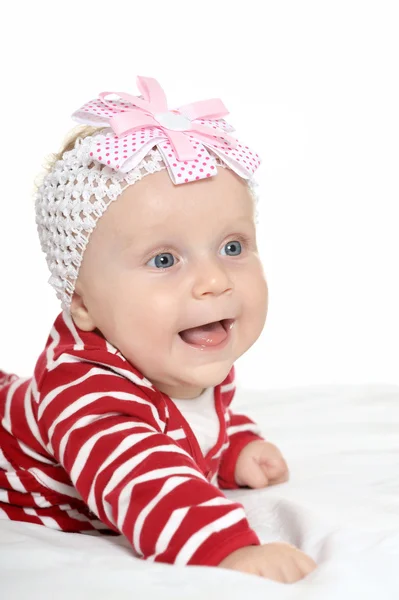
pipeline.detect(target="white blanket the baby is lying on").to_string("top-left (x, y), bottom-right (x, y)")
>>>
top-left (0, 385), bottom-right (399, 600)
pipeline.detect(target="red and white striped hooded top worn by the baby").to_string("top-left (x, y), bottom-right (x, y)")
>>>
top-left (0, 312), bottom-right (261, 565)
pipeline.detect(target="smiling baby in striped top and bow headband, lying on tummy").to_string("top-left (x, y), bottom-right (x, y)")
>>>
top-left (0, 77), bottom-right (316, 582)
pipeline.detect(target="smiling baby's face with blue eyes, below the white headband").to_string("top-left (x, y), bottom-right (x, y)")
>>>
top-left (71, 168), bottom-right (267, 398)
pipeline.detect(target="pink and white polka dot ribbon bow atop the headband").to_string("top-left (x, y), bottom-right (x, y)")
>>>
top-left (72, 77), bottom-right (260, 184)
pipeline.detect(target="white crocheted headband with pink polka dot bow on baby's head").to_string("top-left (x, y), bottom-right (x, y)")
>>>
top-left (35, 77), bottom-right (260, 311)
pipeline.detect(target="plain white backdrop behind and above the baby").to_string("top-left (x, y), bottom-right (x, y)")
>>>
top-left (0, 0), bottom-right (399, 389)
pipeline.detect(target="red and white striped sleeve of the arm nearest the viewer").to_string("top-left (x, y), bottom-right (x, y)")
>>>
top-left (37, 360), bottom-right (260, 565)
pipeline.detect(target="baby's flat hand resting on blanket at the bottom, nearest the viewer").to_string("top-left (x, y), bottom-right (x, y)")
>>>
top-left (219, 542), bottom-right (317, 583)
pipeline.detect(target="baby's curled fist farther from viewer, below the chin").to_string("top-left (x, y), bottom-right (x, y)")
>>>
top-left (234, 440), bottom-right (289, 488)
